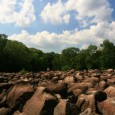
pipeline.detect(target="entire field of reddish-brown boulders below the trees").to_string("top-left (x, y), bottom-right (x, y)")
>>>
top-left (0, 69), bottom-right (115, 115)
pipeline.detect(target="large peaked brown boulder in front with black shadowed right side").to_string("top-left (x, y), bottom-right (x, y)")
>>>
top-left (23, 87), bottom-right (58, 115)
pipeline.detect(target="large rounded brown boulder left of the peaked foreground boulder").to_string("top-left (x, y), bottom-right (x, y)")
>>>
top-left (6, 81), bottom-right (34, 109)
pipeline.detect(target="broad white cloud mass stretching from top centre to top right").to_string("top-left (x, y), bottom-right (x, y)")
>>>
top-left (41, 0), bottom-right (113, 27)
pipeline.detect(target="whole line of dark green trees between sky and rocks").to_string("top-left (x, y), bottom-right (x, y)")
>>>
top-left (0, 34), bottom-right (115, 72)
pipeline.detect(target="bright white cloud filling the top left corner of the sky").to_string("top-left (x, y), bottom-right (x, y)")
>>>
top-left (0, 0), bottom-right (36, 26)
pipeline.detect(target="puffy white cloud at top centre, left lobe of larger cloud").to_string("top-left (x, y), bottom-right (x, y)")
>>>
top-left (40, 0), bottom-right (70, 24)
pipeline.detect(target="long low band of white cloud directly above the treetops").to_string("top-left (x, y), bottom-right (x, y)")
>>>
top-left (8, 21), bottom-right (115, 52)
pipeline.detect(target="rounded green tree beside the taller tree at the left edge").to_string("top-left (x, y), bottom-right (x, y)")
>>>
top-left (4, 40), bottom-right (29, 71)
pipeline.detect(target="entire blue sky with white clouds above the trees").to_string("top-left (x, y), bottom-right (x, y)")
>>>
top-left (0, 0), bottom-right (115, 53)
